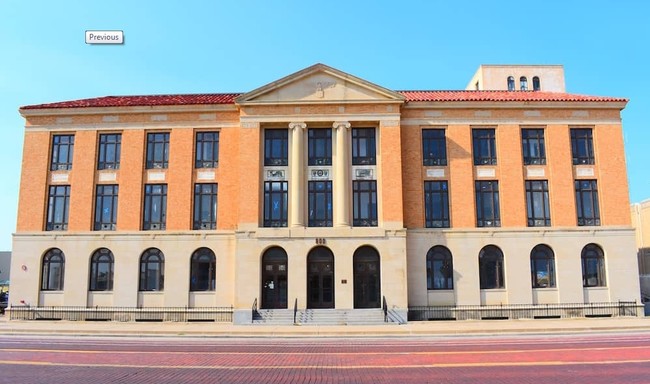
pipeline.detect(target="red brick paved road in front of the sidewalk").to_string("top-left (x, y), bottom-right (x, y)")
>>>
top-left (0, 333), bottom-right (650, 384)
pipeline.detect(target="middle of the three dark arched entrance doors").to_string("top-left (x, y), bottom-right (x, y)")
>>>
top-left (307, 247), bottom-right (334, 308)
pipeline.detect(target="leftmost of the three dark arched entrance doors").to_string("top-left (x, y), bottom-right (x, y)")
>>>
top-left (261, 247), bottom-right (288, 309)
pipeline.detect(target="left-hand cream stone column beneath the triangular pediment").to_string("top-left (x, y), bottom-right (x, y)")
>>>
top-left (288, 123), bottom-right (307, 227)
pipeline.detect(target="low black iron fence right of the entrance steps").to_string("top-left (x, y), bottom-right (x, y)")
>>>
top-left (408, 301), bottom-right (643, 321)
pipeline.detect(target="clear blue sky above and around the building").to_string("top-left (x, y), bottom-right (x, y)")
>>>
top-left (0, 0), bottom-right (650, 250)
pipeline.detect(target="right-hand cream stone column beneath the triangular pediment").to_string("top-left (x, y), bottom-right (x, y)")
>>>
top-left (332, 121), bottom-right (351, 227)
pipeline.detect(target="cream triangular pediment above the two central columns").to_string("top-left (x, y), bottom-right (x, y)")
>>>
top-left (236, 64), bottom-right (404, 105)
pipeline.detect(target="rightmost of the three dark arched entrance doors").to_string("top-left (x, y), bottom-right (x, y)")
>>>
top-left (354, 247), bottom-right (381, 308)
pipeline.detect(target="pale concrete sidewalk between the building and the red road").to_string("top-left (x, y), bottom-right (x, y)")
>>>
top-left (0, 316), bottom-right (650, 337)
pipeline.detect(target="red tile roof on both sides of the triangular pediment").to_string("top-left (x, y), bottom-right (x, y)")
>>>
top-left (21, 91), bottom-right (627, 109)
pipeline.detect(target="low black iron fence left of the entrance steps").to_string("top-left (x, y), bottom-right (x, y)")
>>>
top-left (7, 306), bottom-right (233, 322)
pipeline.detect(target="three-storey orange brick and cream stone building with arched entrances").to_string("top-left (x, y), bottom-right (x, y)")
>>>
top-left (11, 64), bottom-right (639, 322)
